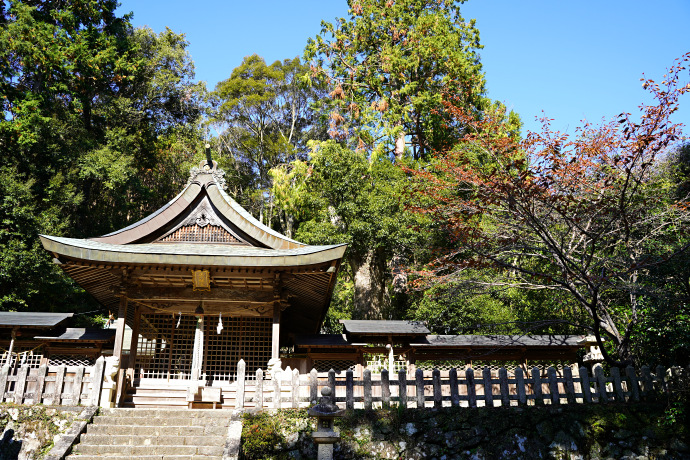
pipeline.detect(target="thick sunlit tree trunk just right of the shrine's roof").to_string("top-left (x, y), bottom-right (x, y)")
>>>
top-left (349, 249), bottom-right (388, 319)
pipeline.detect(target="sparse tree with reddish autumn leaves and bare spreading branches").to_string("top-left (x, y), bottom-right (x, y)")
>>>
top-left (408, 53), bottom-right (690, 365)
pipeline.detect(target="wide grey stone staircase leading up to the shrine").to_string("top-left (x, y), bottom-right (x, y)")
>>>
top-left (67, 409), bottom-right (242, 460)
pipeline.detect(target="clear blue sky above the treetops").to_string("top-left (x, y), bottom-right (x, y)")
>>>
top-left (118, 0), bottom-right (690, 134)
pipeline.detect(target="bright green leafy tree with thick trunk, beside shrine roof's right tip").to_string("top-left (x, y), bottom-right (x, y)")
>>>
top-left (273, 140), bottom-right (424, 319)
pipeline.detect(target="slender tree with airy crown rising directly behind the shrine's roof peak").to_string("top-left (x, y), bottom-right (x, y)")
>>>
top-left (210, 54), bottom-right (325, 235)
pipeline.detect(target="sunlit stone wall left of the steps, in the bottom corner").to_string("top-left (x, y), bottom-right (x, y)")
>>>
top-left (0, 403), bottom-right (83, 460)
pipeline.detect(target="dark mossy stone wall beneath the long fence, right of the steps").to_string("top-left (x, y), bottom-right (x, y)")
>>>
top-left (242, 403), bottom-right (690, 460)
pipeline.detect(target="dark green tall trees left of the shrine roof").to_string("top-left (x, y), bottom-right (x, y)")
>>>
top-left (0, 0), bottom-right (201, 310)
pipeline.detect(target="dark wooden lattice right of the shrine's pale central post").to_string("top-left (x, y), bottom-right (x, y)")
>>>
top-left (202, 317), bottom-right (271, 381)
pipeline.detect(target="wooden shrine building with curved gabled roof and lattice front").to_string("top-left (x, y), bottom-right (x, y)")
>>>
top-left (41, 161), bottom-right (347, 385)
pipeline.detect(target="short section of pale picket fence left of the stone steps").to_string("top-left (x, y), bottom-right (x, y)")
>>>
top-left (0, 359), bottom-right (104, 406)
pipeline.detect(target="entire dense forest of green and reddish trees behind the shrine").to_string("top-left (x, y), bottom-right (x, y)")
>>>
top-left (0, 0), bottom-right (690, 365)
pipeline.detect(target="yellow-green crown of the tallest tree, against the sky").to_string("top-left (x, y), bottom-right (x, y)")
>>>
top-left (305, 0), bottom-right (484, 158)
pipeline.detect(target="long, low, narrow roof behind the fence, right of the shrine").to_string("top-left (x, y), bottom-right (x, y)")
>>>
top-left (410, 335), bottom-right (582, 348)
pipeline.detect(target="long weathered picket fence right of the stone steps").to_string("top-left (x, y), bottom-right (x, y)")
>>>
top-left (230, 361), bottom-right (676, 409)
